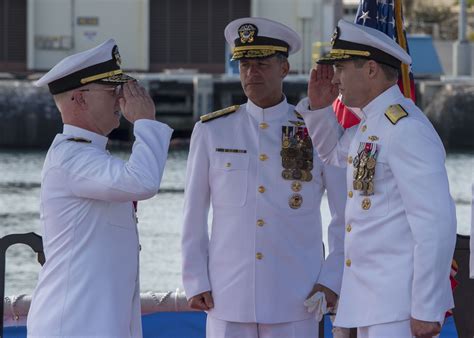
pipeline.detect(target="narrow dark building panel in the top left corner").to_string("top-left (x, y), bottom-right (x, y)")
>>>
top-left (0, 0), bottom-right (27, 72)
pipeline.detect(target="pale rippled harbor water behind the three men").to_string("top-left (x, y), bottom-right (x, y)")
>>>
top-left (0, 150), bottom-right (474, 295)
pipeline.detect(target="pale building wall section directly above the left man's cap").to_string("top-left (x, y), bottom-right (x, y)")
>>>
top-left (27, 0), bottom-right (149, 71)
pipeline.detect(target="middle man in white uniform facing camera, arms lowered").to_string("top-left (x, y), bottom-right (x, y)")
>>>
top-left (182, 18), bottom-right (345, 338)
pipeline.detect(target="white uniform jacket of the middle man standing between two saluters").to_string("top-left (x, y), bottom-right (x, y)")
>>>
top-left (182, 99), bottom-right (345, 323)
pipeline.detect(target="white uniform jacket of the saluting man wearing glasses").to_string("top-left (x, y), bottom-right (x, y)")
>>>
top-left (27, 120), bottom-right (172, 337)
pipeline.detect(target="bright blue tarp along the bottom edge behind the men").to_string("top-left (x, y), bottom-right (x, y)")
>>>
top-left (4, 312), bottom-right (458, 338)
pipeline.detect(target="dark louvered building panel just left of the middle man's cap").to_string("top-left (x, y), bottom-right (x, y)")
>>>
top-left (150, 0), bottom-right (250, 73)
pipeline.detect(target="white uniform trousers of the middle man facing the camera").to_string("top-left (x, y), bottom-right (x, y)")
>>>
top-left (206, 315), bottom-right (319, 338)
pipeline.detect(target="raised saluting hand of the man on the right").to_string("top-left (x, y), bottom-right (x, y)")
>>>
top-left (308, 64), bottom-right (339, 110)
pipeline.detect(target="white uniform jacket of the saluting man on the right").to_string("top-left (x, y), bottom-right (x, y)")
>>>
top-left (297, 86), bottom-right (456, 327)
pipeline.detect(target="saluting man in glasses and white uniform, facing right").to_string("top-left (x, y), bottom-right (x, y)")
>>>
top-left (27, 39), bottom-right (172, 338)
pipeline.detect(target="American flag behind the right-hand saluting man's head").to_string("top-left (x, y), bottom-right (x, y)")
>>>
top-left (333, 0), bottom-right (415, 128)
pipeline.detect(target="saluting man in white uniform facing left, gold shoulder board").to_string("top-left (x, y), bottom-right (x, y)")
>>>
top-left (297, 21), bottom-right (456, 338)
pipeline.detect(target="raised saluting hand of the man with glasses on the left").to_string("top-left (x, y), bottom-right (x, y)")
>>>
top-left (119, 81), bottom-right (155, 123)
